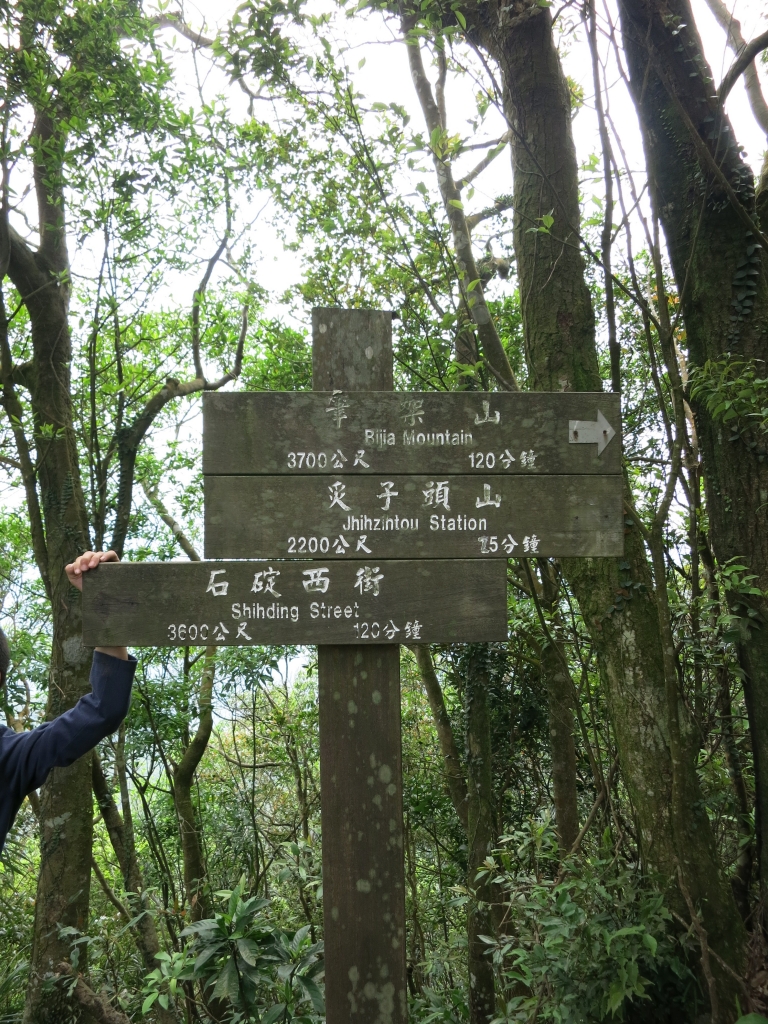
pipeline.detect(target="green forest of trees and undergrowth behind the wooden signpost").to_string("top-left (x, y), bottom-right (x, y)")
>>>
top-left (0, 0), bottom-right (768, 1024)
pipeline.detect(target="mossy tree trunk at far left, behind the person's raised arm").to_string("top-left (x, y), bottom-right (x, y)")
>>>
top-left (2, 114), bottom-right (93, 1024)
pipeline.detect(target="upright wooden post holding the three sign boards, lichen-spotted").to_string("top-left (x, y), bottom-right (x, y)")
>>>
top-left (312, 309), bottom-right (408, 1024)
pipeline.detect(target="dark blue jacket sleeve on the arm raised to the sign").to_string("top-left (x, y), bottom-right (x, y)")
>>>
top-left (0, 651), bottom-right (136, 800)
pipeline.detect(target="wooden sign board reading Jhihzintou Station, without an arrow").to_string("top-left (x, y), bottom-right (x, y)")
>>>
top-left (205, 476), bottom-right (624, 558)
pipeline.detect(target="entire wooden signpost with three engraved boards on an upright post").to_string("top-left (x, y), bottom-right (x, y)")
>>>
top-left (83, 309), bottom-right (624, 1024)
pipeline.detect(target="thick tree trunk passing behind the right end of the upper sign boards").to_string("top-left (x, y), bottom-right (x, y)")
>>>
top-left (462, 3), bottom-right (753, 1007)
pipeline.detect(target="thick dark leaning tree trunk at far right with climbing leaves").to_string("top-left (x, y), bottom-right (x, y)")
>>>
top-left (620, 0), bottom-right (768, 921)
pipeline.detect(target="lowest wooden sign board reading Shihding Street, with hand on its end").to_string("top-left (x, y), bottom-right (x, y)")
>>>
top-left (83, 559), bottom-right (507, 647)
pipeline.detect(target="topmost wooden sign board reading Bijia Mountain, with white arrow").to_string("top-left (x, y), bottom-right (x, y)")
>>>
top-left (203, 391), bottom-right (622, 476)
